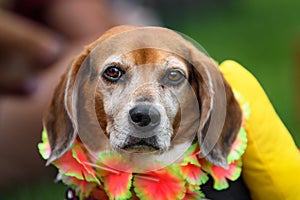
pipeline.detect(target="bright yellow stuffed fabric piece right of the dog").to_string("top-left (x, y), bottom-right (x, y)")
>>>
top-left (220, 61), bottom-right (300, 200)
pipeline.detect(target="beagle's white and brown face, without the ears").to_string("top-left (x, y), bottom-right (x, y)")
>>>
top-left (96, 49), bottom-right (190, 152)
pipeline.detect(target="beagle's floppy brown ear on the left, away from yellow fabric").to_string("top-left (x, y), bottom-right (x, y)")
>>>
top-left (43, 49), bottom-right (89, 165)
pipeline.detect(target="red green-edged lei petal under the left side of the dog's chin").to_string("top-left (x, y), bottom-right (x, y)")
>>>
top-left (97, 152), bottom-right (132, 200)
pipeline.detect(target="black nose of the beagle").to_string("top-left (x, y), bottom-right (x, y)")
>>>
top-left (129, 105), bottom-right (160, 129)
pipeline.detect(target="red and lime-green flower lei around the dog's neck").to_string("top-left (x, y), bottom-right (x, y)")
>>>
top-left (38, 92), bottom-right (250, 200)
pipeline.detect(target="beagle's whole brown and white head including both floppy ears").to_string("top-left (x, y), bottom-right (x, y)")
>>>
top-left (44, 26), bottom-right (241, 167)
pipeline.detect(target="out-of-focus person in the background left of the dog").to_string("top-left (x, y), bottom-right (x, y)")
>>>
top-left (0, 0), bottom-right (160, 188)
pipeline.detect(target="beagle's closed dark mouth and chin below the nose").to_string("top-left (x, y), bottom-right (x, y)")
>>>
top-left (122, 136), bottom-right (160, 153)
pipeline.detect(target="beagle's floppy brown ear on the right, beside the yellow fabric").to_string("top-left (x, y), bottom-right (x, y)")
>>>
top-left (190, 48), bottom-right (242, 168)
